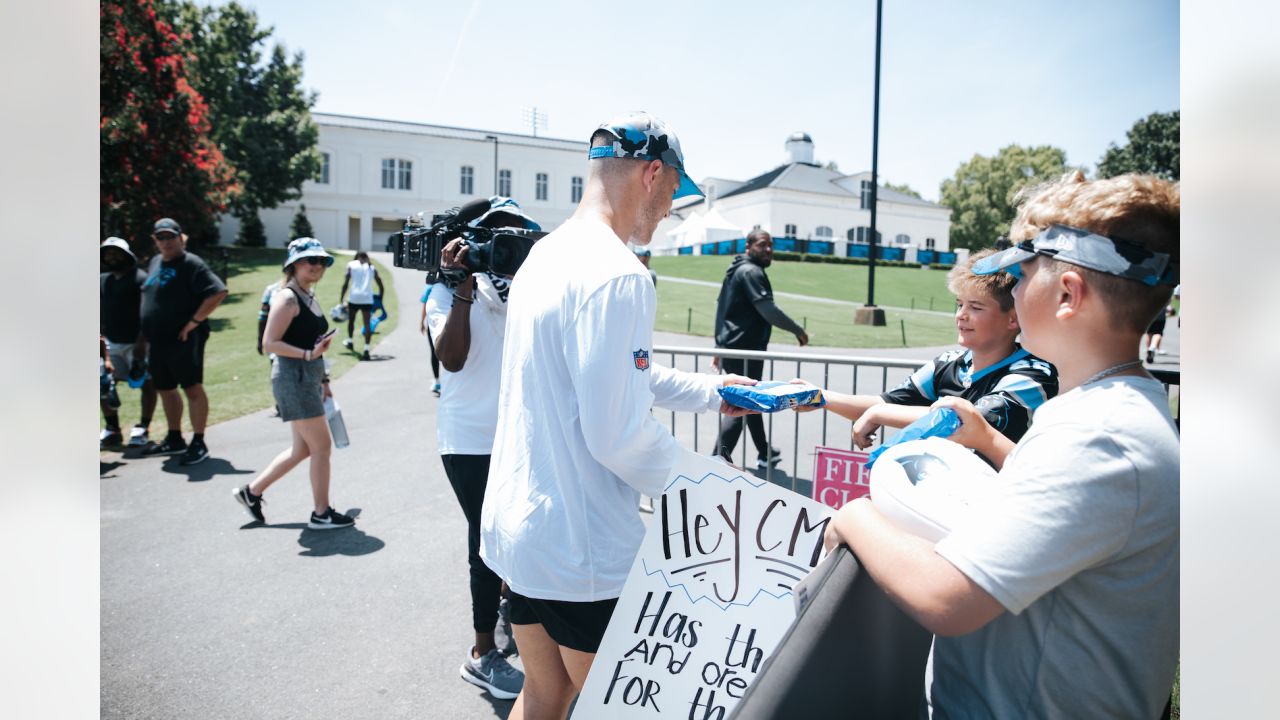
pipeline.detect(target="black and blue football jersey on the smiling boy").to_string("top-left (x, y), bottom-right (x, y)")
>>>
top-left (881, 346), bottom-right (1057, 442)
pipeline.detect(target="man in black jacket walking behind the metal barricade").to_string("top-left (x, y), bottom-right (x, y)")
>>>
top-left (712, 229), bottom-right (809, 470)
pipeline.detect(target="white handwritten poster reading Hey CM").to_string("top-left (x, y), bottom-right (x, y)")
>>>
top-left (573, 451), bottom-right (831, 720)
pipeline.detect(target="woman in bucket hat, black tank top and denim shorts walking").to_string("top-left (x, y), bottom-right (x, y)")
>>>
top-left (232, 237), bottom-right (355, 530)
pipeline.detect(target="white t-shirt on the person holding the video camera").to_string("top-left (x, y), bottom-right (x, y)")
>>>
top-left (426, 274), bottom-right (507, 455)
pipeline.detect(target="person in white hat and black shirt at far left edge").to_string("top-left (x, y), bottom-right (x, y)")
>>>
top-left (97, 237), bottom-right (156, 448)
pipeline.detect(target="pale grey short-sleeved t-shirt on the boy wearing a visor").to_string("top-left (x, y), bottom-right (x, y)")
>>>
top-left (925, 377), bottom-right (1179, 717)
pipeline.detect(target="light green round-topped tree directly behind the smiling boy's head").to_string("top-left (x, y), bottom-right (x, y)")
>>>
top-left (942, 145), bottom-right (1068, 250)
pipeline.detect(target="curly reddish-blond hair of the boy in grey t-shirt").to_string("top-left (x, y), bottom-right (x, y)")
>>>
top-left (1009, 170), bottom-right (1181, 334)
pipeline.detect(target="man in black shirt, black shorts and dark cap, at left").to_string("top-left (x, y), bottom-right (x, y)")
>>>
top-left (142, 218), bottom-right (227, 465)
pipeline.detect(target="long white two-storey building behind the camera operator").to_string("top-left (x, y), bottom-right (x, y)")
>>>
top-left (220, 113), bottom-right (586, 250)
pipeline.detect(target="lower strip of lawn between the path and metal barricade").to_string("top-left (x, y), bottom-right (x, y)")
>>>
top-left (654, 279), bottom-right (956, 347)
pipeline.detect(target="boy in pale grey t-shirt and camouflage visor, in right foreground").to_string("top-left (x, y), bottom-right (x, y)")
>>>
top-left (827, 172), bottom-right (1180, 717)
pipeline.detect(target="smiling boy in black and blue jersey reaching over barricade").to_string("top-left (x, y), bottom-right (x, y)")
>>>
top-left (823, 250), bottom-right (1057, 458)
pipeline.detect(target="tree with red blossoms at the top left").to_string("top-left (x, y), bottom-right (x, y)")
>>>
top-left (99, 0), bottom-right (241, 244)
